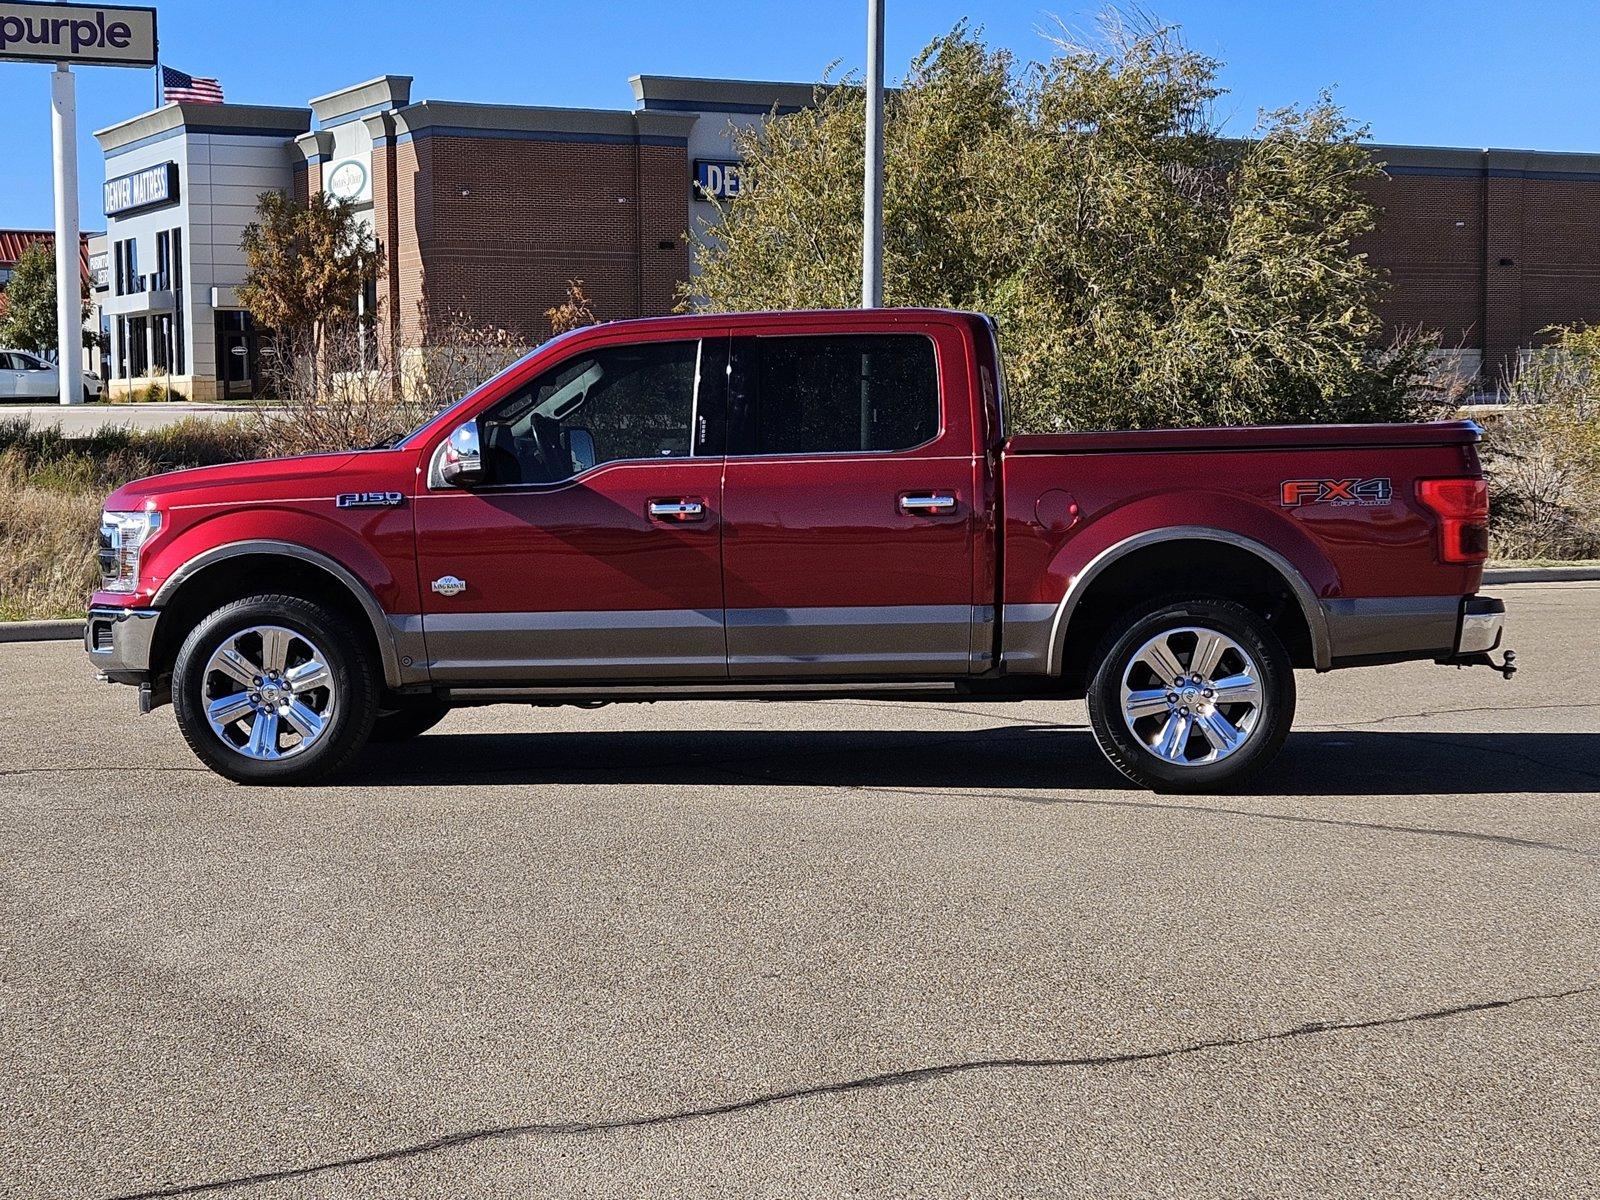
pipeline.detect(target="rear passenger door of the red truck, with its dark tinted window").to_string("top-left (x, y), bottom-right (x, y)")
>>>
top-left (723, 326), bottom-right (976, 678)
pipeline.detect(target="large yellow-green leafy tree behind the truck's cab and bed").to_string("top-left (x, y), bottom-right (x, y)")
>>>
top-left (683, 16), bottom-right (1432, 430)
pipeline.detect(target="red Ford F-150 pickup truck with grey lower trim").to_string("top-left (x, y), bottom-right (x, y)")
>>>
top-left (86, 309), bottom-right (1506, 790)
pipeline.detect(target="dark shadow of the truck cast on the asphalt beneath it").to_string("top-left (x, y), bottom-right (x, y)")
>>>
top-left (356, 722), bottom-right (1600, 803)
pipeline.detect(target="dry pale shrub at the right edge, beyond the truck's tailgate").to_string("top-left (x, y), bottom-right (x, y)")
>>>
top-left (1483, 328), bottom-right (1600, 558)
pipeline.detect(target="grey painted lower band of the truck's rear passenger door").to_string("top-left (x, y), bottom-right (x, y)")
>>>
top-left (728, 605), bottom-right (974, 678)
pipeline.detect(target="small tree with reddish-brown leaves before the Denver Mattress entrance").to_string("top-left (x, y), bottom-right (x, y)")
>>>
top-left (238, 192), bottom-right (381, 347)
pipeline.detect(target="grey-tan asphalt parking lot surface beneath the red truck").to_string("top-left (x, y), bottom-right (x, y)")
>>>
top-left (0, 584), bottom-right (1600, 1198)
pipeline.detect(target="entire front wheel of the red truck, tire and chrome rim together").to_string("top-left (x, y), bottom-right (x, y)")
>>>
top-left (173, 595), bottom-right (378, 784)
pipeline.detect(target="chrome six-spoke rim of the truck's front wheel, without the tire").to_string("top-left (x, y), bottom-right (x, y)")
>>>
top-left (200, 626), bottom-right (338, 760)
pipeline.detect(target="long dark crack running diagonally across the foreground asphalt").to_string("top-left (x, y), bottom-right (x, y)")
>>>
top-left (114, 982), bottom-right (1600, 1200)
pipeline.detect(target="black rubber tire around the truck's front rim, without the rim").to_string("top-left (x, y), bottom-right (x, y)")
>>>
top-left (173, 595), bottom-right (379, 784)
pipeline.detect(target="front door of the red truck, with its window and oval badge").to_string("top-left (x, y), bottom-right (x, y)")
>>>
top-left (416, 339), bottom-right (726, 683)
